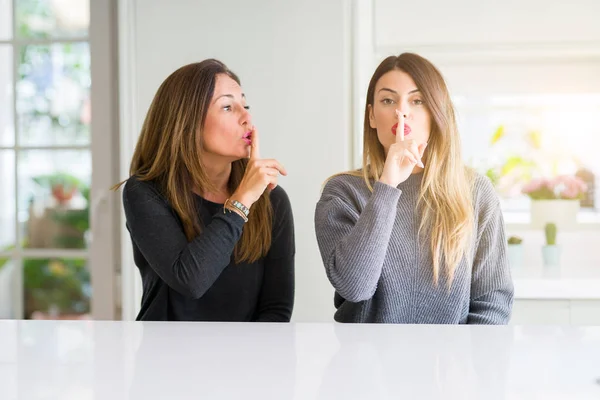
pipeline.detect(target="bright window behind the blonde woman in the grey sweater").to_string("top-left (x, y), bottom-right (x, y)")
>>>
top-left (374, 44), bottom-right (600, 219)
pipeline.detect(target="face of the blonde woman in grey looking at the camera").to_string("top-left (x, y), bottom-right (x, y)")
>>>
top-left (369, 70), bottom-right (431, 155)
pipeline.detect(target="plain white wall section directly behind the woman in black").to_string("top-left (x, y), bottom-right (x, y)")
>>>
top-left (121, 0), bottom-right (352, 321)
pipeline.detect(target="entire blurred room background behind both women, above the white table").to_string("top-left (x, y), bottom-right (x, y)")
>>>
top-left (0, 0), bottom-right (600, 325)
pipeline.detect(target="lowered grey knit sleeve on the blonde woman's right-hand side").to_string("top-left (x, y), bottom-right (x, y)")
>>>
top-left (467, 177), bottom-right (514, 325)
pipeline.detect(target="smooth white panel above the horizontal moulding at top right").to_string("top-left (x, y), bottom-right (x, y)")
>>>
top-left (373, 0), bottom-right (600, 48)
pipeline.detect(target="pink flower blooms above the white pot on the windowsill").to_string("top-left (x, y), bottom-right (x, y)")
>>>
top-left (522, 175), bottom-right (587, 200)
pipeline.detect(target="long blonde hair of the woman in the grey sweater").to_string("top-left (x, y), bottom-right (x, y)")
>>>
top-left (336, 53), bottom-right (475, 285)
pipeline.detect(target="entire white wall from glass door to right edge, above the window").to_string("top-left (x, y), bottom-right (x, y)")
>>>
top-left (120, 0), bottom-right (600, 321)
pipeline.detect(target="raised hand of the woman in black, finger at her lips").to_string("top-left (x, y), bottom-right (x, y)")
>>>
top-left (231, 127), bottom-right (287, 208)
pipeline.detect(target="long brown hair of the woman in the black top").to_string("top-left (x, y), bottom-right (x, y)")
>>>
top-left (113, 59), bottom-right (273, 263)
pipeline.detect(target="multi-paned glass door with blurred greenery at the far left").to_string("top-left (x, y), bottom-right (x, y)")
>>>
top-left (0, 0), bottom-right (92, 318)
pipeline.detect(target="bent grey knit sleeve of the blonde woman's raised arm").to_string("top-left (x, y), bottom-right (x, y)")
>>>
top-left (315, 178), bottom-right (401, 303)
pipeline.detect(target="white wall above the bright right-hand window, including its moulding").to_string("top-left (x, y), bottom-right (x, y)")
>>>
top-left (373, 0), bottom-right (600, 95)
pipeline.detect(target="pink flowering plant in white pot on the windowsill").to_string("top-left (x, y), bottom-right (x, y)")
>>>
top-left (522, 175), bottom-right (587, 229)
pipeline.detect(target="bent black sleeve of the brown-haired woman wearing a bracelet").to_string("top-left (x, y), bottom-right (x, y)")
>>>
top-left (123, 178), bottom-right (244, 299)
